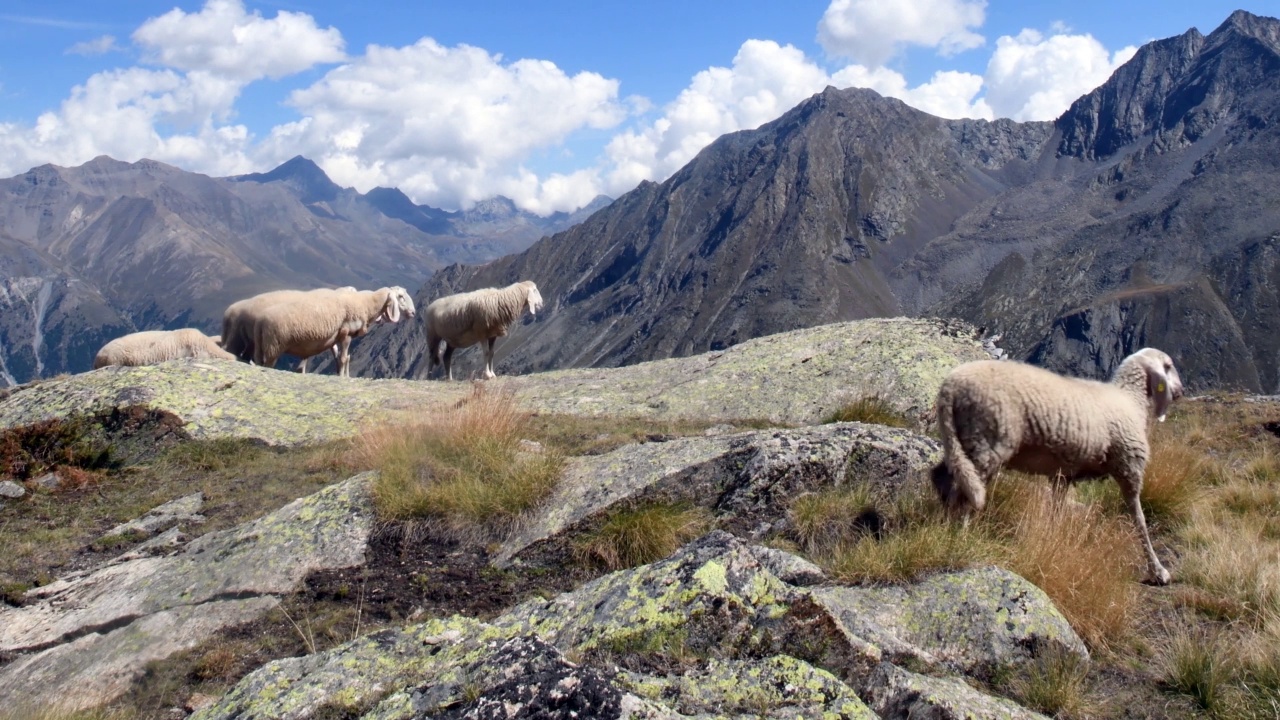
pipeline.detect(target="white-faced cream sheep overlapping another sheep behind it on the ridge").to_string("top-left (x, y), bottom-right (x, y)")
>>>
top-left (253, 287), bottom-right (416, 377)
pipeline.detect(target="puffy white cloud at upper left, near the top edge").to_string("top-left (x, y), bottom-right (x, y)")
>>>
top-left (133, 0), bottom-right (343, 82)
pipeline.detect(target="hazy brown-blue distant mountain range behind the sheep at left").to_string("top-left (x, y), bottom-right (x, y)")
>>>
top-left (0, 156), bottom-right (609, 386)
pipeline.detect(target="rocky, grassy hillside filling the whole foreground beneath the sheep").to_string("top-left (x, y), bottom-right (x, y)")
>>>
top-left (0, 319), bottom-right (1280, 720)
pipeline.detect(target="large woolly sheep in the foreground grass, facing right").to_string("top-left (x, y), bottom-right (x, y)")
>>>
top-left (932, 347), bottom-right (1183, 585)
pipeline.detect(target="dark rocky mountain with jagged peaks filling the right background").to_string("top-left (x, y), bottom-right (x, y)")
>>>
top-left (356, 12), bottom-right (1280, 392)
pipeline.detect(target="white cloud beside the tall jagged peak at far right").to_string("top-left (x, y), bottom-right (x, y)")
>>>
top-left (986, 29), bottom-right (1138, 120)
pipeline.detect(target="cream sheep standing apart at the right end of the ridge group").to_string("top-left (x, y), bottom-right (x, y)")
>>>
top-left (422, 281), bottom-right (543, 380)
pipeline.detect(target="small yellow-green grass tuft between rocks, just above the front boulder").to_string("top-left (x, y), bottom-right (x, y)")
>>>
top-left (573, 505), bottom-right (713, 570)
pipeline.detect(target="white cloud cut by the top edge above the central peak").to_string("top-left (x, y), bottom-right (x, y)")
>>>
top-left (818, 0), bottom-right (987, 67)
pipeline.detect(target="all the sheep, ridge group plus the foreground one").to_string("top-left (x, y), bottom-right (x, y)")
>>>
top-left (93, 281), bottom-right (1183, 584)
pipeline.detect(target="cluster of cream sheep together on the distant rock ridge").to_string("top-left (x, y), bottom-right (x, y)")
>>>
top-left (93, 281), bottom-right (543, 379)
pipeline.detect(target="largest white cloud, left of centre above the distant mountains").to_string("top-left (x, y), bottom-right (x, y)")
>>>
top-left (264, 38), bottom-right (627, 213)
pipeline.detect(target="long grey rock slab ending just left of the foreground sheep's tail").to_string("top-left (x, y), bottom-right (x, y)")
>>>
top-left (494, 423), bottom-right (938, 565)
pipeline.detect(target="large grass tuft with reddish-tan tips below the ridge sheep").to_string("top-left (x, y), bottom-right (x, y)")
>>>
top-left (352, 384), bottom-right (563, 537)
